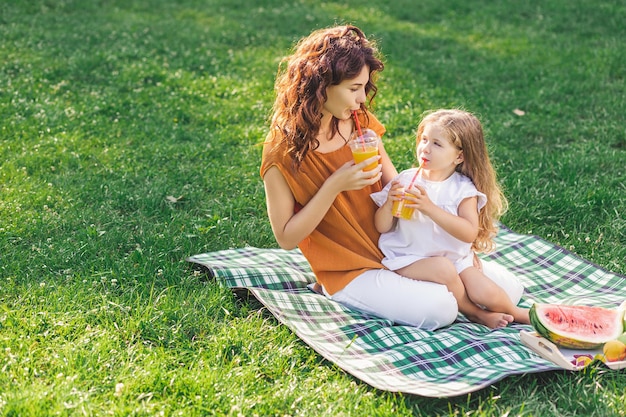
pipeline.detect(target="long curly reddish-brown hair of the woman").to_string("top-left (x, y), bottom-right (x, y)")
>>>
top-left (270, 25), bottom-right (384, 168)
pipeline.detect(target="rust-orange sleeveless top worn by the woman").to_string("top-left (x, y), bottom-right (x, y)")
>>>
top-left (260, 113), bottom-right (385, 295)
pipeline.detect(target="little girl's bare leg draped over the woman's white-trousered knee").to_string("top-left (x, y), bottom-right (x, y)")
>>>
top-left (396, 257), bottom-right (514, 329)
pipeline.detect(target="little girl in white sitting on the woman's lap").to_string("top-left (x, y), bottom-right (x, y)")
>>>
top-left (372, 110), bottom-right (529, 328)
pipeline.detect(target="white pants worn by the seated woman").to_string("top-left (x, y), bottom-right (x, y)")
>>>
top-left (324, 261), bottom-right (524, 330)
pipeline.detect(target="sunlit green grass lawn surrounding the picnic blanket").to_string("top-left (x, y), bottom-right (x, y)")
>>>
top-left (0, 0), bottom-right (626, 416)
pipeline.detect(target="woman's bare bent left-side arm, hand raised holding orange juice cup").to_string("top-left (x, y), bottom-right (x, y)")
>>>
top-left (263, 155), bottom-right (382, 249)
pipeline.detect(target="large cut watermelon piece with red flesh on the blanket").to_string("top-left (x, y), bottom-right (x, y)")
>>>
top-left (530, 304), bottom-right (624, 349)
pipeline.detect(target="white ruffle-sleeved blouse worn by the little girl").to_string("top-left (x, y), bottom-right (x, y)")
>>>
top-left (371, 168), bottom-right (487, 272)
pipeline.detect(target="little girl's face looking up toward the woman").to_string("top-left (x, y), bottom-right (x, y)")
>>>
top-left (417, 123), bottom-right (463, 174)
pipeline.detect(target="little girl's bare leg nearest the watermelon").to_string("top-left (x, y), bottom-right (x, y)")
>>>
top-left (459, 266), bottom-right (530, 324)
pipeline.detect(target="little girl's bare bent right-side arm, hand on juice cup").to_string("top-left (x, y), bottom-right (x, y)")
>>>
top-left (410, 185), bottom-right (478, 243)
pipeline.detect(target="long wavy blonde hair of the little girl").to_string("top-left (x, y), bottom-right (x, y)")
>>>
top-left (417, 109), bottom-right (508, 252)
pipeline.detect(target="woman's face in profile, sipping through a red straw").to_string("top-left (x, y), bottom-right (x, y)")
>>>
top-left (322, 65), bottom-right (370, 120)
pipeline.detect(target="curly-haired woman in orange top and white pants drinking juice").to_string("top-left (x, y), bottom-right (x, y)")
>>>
top-left (261, 25), bottom-right (458, 330)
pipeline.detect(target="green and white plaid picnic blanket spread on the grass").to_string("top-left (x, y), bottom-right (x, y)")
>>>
top-left (187, 226), bottom-right (626, 397)
